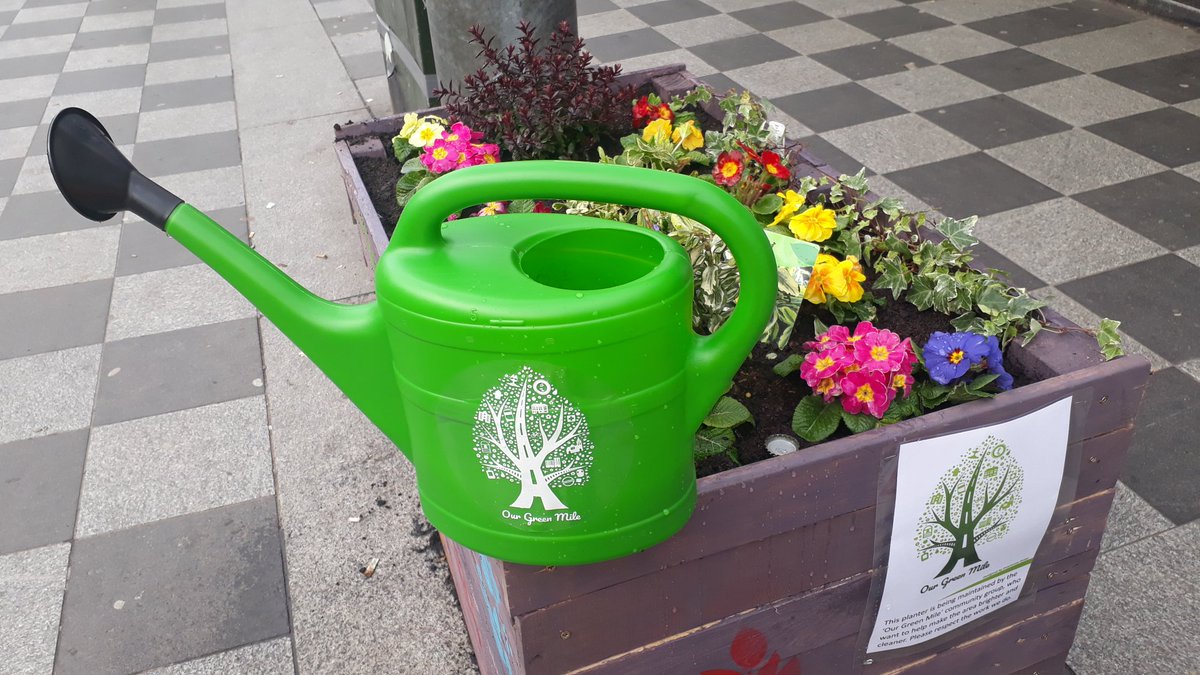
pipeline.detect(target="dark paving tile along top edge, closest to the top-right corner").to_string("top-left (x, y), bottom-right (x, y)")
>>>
top-left (965, 2), bottom-right (1134, 44)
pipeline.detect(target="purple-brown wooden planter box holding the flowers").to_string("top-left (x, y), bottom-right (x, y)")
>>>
top-left (336, 66), bottom-right (1150, 675)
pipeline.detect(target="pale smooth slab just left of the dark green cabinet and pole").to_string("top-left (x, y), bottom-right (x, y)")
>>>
top-left (229, 17), bottom-right (362, 130)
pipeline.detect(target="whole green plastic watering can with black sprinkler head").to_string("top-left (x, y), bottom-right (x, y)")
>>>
top-left (48, 108), bottom-right (776, 565)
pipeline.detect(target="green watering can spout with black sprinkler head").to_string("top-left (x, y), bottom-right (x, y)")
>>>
top-left (47, 108), bottom-right (408, 453)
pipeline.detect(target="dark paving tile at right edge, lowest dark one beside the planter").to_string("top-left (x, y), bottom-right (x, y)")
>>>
top-left (1121, 368), bottom-right (1200, 525)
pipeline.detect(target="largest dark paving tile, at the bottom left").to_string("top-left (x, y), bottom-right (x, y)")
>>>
top-left (54, 497), bottom-right (288, 675)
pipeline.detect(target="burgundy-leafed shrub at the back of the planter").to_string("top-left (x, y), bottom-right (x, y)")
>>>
top-left (433, 22), bottom-right (632, 160)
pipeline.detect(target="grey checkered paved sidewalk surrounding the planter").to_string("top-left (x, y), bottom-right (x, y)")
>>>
top-left (0, 0), bottom-right (1200, 675)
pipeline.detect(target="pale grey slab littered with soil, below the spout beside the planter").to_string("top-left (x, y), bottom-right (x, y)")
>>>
top-left (263, 322), bottom-right (473, 675)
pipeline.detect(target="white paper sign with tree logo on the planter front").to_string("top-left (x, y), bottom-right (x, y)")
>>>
top-left (866, 398), bottom-right (1070, 652)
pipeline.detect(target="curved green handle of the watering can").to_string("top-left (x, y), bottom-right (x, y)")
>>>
top-left (391, 161), bottom-right (778, 426)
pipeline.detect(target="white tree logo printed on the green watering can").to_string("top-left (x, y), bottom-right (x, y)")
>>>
top-left (473, 366), bottom-right (594, 510)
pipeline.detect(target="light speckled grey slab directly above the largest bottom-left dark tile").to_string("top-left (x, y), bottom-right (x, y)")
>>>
top-left (76, 395), bottom-right (275, 537)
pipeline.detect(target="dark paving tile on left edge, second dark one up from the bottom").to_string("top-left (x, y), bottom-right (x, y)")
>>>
top-left (0, 279), bottom-right (113, 357)
